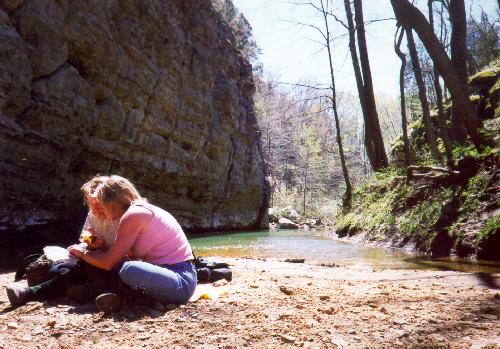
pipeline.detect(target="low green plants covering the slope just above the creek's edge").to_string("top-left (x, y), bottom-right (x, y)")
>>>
top-left (335, 160), bottom-right (500, 251)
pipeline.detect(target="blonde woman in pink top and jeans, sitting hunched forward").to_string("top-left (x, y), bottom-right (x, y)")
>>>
top-left (69, 176), bottom-right (196, 305)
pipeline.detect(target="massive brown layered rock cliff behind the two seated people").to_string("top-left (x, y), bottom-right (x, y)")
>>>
top-left (0, 0), bottom-right (267, 250)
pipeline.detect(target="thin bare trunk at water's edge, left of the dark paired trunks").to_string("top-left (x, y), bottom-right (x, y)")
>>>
top-left (321, 0), bottom-right (352, 207)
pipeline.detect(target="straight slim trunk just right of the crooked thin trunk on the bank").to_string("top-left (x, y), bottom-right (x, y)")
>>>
top-left (406, 29), bottom-right (441, 161)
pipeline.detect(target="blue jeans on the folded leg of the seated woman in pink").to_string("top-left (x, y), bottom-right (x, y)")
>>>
top-left (118, 261), bottom-right (197, 304)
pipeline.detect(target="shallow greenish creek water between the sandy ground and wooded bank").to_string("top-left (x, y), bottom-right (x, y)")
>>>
top-left (189, 230), bottom-right (500, 273)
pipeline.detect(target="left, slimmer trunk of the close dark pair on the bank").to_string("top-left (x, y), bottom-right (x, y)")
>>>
top-left (344, 0), bottom-right (376, 169)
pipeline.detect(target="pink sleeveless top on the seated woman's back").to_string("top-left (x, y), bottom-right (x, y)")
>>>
top-left (131, 202), bottom-right (193, 265)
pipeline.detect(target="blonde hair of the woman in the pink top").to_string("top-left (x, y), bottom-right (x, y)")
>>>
top-left (95, 175), bottom-right (146, 207)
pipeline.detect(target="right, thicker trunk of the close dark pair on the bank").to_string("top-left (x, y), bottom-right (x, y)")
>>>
top-left (354, 0), bottom-right (389, 171)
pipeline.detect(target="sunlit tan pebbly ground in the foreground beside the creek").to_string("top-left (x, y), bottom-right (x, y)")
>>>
top-left (0, 259), bottom-right (500, 348)
